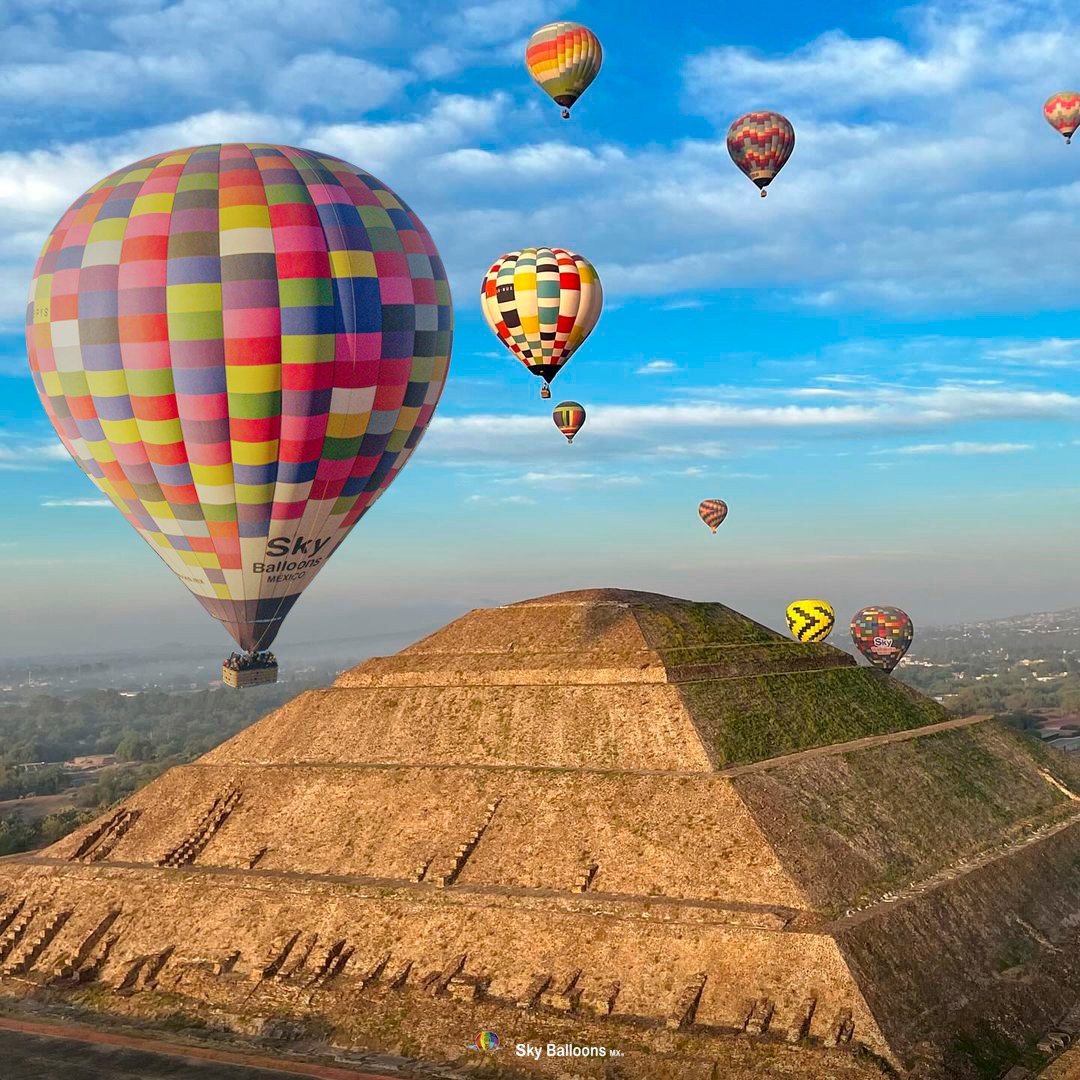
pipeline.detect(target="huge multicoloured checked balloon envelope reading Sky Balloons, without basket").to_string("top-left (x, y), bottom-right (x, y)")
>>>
top-left (26, 144), bottom-right (453, 686)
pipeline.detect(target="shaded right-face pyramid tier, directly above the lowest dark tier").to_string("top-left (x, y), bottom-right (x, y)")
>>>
top-left (733, 721), bottom-right (1080, 913)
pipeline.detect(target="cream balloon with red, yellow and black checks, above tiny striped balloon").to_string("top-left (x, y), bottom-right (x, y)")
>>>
top-left (480, 247), bottom-right (604, 397)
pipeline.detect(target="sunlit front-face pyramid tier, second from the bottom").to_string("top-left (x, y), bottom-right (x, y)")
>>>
top-left (45, 765), bottom-right (806, 907)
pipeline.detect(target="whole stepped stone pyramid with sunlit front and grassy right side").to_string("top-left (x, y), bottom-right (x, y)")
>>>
top-left (0, 590), bottom-right (1080, 1080)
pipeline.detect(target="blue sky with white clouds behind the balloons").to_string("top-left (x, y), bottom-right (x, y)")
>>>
top-left (0, 0), bottom-right (1080, 653)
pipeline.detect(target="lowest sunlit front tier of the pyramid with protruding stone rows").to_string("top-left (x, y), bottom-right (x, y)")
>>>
top-left (0, 865), bottom-right (886, 1053)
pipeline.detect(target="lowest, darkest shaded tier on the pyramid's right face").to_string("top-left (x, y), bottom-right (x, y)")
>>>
top-left (834, 822), bottom-right (1080, 1076)
